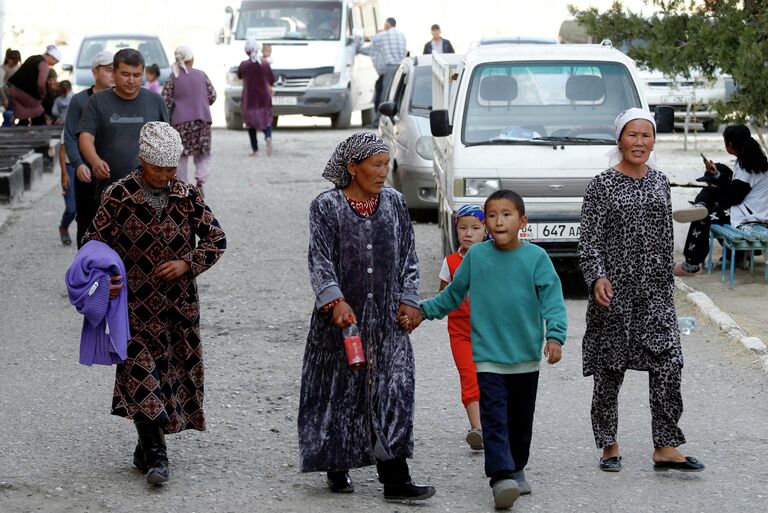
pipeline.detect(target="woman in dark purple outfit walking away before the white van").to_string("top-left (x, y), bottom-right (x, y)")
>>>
top-left (237, 39), bottom-right (275, 157)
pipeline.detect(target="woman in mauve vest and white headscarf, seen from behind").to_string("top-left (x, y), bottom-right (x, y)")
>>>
top-left (162, 46), bottom-right (216, 192)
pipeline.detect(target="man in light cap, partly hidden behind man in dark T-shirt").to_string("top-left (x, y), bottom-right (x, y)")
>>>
top-left (59, 50), bottom-right (115, 248)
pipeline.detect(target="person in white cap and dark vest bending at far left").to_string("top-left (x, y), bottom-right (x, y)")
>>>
top-left (8, 45), bottom-right (61, 125)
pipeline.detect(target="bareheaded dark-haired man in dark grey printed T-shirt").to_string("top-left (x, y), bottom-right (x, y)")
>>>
top-left (77, 48), bottom-right (168, 242)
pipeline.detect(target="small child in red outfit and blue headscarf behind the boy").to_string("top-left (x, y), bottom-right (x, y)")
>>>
top-left (440, 205), bottom-right (485, 451)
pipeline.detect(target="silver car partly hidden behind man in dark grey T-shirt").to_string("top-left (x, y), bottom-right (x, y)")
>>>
top-left (62, 33), bottom-right (171, 92)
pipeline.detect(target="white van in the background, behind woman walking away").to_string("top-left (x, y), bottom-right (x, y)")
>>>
top-left (218, 0), bottom-right (384, 129)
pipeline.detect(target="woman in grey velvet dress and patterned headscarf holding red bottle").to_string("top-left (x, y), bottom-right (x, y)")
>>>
top-left (298, 132), bottom-right (435, 500)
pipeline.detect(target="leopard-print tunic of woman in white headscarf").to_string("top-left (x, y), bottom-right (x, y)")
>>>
top-left (579, 168), bottom-right (683, 376)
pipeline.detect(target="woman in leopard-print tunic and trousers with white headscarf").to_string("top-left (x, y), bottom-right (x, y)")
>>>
top-left (579, 109), bottom-right (704, 472)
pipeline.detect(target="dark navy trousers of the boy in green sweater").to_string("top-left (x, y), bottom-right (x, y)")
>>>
top-left (477, 371), bottom-right (539, 486)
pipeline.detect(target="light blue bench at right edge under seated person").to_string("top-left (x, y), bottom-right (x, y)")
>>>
top-left (707, 224), bottom-right (768, 289)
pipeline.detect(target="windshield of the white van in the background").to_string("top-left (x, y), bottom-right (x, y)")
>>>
top-left (235, 1), bottom-right (341, 41)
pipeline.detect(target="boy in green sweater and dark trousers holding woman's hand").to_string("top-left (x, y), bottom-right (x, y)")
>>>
top-left (412, 190), bottom-right (568, 509)
